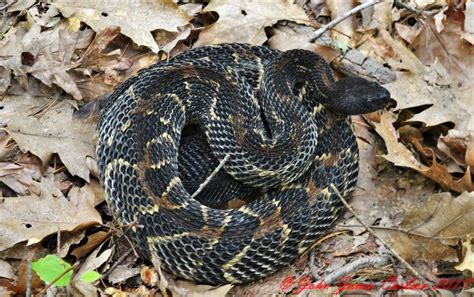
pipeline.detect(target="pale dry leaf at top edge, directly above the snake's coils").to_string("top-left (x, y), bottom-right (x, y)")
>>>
top-left (195, 0), bottom-right (309, 46)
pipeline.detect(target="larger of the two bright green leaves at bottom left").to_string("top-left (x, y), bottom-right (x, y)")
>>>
top-left (31, 255), bottom-right (72, 287)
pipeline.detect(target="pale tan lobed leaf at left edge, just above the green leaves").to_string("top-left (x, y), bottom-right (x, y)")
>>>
top-left (0, 174), bottom-right (102, 250)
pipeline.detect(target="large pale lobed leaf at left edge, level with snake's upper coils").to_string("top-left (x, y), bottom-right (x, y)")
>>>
top-left (0, 96), bottom-right (95, 181)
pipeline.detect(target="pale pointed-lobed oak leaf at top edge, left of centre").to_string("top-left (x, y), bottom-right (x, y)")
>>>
top-left (52, 0), bottom-right (190, 52)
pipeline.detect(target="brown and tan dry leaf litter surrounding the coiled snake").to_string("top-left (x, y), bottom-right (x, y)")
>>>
top-left (0, 0), bottom-right (474, 296)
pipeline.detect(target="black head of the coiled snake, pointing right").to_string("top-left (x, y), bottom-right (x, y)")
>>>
top-left (328, 76), bottom-right (390, 115)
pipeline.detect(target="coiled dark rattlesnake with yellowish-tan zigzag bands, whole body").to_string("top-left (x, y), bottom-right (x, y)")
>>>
top-left (97, 44), bottom-right (390, 284)
